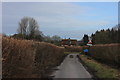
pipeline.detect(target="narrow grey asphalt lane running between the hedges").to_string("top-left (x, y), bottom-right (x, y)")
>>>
top-left (54, 54), bottom-right (92, 80)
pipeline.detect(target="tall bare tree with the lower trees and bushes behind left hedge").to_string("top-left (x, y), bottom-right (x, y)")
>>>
top-left (12, 17), bottom-right (61, 45)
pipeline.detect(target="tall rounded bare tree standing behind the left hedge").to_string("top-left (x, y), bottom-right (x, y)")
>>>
top-left (17, 17), bottom-right (40, 38)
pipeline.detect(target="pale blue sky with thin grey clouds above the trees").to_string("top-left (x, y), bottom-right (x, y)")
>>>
top-left (2, 2), bottom-right (118, 39)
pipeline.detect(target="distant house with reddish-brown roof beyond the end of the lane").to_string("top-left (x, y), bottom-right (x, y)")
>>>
top-left (61, 38), bottom-right (77, 46)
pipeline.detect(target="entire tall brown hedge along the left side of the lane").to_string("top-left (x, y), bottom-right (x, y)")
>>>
top-left (2, 37), bottom-right (64, 78)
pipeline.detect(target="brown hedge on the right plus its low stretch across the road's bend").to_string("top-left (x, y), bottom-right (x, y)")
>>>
top-left (65, 43), bottom-right (120, 68)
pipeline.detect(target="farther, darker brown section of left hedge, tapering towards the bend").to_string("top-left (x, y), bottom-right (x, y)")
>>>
top-left (35, 42), bottom-right (64, 77)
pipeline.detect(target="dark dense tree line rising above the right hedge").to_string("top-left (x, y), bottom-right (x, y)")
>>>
top-left (91, 24), bottom-right (120, 44)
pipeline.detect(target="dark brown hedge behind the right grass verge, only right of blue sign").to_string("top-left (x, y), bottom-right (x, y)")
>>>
top-left (89, 44), bottom-right (120, 67)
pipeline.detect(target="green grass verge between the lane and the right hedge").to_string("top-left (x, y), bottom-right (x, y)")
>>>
top-left (80, 55), bottom-right (120, 79)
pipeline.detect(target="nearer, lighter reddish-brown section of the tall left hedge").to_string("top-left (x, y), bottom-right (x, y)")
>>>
top-left (2, 37), bottom-right (35, 78)
